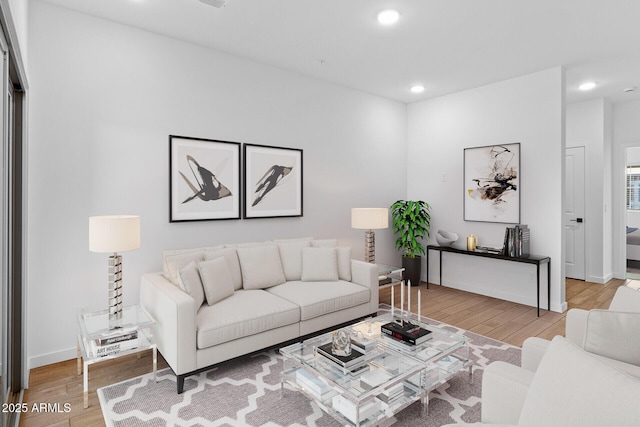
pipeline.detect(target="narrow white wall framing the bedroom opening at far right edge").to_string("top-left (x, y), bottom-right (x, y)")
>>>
top-left (612, 101), bottom-right (640, 279)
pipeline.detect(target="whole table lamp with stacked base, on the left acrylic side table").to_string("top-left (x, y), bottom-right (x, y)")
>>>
top-left (89, 215), bottom-right (140, 329)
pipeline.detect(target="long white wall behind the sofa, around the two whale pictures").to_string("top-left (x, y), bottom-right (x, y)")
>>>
top-left (28, 2), bottom-right (406, 367)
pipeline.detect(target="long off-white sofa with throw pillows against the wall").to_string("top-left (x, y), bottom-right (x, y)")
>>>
top-left (140, 238), bottom-right (378, 393)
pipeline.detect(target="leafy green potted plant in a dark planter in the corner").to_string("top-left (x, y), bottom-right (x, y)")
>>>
top-left (391, 200), bottom-right (431, 286)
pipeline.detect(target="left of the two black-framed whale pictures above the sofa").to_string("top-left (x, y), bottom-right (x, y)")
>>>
top-left (169, 135), bottom-right (242, 222)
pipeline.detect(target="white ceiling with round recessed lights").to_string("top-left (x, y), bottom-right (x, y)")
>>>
top-left (38, 0), bottom-right (640, 103)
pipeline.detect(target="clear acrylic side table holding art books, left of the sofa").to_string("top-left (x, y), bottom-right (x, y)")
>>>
top-left (77, 305), bottom-right (158, 408)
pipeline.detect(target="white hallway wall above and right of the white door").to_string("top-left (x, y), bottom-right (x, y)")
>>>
top-left (566, 99), bottom-right (613, 283)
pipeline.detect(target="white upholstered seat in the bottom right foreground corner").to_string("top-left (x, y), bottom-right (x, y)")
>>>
top-left (442, 336), bottom-right (640, 427)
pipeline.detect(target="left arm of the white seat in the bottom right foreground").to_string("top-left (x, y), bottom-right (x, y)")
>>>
top-left (481, 362), bottom-right (534, 425)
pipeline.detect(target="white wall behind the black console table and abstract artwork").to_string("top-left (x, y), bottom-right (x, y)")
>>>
top-left (407, 68), bottom-right (566, 311)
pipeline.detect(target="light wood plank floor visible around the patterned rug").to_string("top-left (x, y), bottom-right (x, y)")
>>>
top-left (20, 279), bottom-right (640, 427)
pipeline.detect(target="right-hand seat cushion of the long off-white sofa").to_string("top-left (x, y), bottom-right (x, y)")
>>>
top-left (267, 280), bottom-right (371, 320)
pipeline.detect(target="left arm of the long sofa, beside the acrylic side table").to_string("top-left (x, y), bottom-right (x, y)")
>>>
top-left (140, 273), bottom-right (197, 375)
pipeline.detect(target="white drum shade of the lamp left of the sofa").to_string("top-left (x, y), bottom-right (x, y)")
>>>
top-left (89, 215), bottom-right (140, 252)
